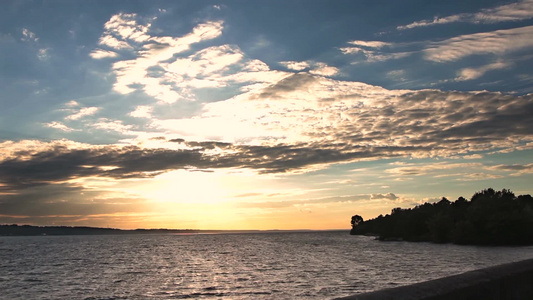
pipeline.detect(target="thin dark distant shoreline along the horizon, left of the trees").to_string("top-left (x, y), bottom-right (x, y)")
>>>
top-left (0, 224), bottom-right (349, 236)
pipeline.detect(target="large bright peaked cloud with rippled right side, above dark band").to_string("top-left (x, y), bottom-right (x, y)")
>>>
top-left (154, 73), bottom-right (533, 161)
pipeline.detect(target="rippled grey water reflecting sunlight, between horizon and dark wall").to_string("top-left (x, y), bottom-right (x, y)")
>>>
top-left (0, 232), bottom-right (533, 299)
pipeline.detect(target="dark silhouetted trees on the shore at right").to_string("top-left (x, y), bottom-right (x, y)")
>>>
top-left (350, 188), bottom-right (533, 245)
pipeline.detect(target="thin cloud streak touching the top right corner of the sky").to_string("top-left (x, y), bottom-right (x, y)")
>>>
top-left (397, 0), bottom-right (533, 30)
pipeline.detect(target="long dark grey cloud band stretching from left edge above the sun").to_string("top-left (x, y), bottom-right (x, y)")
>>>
top-left (0, 142), bottom-right (428, 192)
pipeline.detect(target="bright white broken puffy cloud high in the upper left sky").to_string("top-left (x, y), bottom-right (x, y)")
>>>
top-left (95, 15), bottom-right (288, 103)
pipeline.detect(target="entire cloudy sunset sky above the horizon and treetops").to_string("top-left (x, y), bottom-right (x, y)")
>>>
top-left (0, 0), bottom-right (533, 230)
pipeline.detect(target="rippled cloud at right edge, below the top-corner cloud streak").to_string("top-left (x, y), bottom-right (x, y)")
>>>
top-left (424, 26), bottom-right (533, 62)
